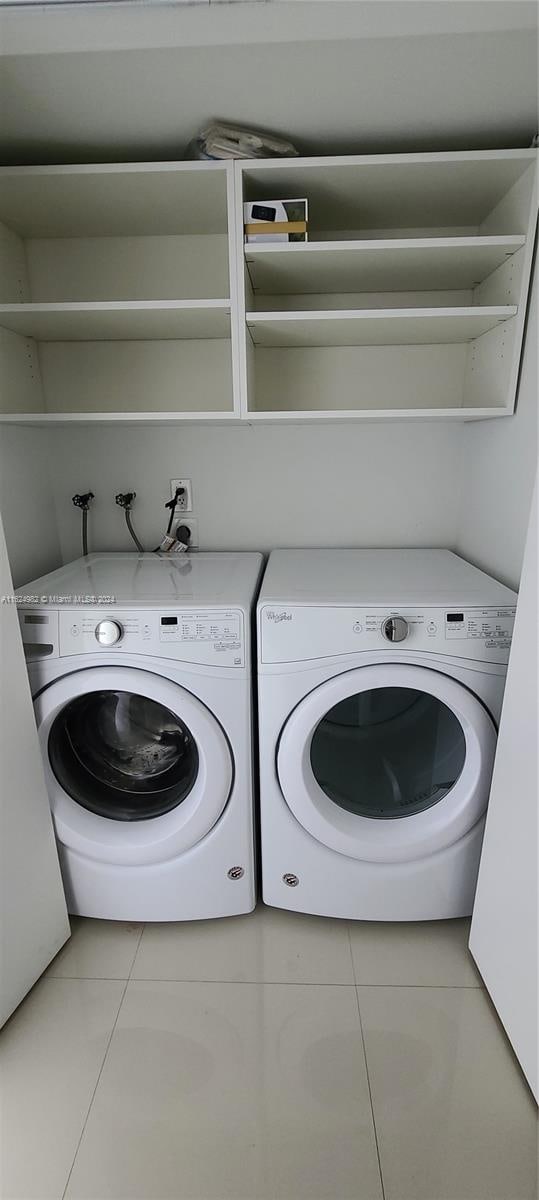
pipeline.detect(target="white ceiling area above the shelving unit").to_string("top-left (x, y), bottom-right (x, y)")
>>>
top-left (0, 0), bottom-right (538, 162)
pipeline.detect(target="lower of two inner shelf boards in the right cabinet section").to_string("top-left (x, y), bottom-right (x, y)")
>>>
top-left (246, 305), bottom-right (517, 348)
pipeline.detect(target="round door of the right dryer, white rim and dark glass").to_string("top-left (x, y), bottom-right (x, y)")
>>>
top-left (277, 664), bottom-right (496, 863)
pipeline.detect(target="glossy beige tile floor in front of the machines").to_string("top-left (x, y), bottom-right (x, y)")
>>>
top-left (0, 906), bottom-right (537, 1200)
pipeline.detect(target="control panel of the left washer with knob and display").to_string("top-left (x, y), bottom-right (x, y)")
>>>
top-left (51, 608), bottom-right (245, 667)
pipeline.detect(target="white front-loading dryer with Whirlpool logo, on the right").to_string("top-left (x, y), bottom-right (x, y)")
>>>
top-left (257, 550), bottom-right (517, 920)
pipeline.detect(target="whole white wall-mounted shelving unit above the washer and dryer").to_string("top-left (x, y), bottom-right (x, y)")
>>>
top-left (0, 150), bottom-right (537, 424)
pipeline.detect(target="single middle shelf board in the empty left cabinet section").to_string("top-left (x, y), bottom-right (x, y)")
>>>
top-left (0, 300), bottom-right (230, 342)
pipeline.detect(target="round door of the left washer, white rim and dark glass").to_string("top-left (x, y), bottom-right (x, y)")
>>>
top-left (35, 666), bottom-right (233, 865)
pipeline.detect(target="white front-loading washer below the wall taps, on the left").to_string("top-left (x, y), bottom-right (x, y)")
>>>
top-left (18, 553), bottom-right (262, 922)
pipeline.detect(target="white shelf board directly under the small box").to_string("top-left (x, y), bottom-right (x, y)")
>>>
top-left (245, 236), bottom-right (526, 295)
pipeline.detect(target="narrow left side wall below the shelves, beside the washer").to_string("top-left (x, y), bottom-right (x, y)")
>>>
top-left (0, 425), bottom-right (61, 587)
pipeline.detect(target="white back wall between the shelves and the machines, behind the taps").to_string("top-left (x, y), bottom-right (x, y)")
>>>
top-left (48, 422), bottom-right (462, 560)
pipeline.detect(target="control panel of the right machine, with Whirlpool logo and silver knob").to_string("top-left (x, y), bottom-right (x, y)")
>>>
top-left (258, 604), bottom-right (516, 664)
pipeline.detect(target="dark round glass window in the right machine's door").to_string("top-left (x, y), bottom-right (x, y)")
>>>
top-left (311, 688), bottom-right (466, 820)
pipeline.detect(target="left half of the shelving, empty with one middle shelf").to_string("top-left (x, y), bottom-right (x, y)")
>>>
top-left (0, 163), bottom-right (239, 421)
